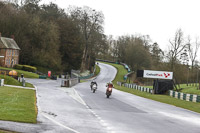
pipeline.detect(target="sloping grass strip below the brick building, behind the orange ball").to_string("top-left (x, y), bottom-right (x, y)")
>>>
top-left (0, 67), bottom-right (39, 78)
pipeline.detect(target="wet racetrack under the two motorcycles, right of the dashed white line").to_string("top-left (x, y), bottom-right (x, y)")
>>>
top-left (75, 64), bottom-right (200, 133)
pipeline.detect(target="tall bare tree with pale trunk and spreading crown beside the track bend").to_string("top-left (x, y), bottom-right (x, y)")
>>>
top-left (69, 6), bottom-right (104, 71)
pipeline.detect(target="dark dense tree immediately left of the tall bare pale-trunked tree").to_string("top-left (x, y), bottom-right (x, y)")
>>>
top-left (58, 17), bottom-right (83, 72)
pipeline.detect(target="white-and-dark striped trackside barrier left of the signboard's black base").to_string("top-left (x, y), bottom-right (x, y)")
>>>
top-left (117, 82), bottom-right (153, 94)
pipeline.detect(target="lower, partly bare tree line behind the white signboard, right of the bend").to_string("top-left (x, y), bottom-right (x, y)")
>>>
top-left (103, 29), bottom-right (200, 84)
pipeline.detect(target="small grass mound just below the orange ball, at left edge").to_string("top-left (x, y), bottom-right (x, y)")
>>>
top-left (0, 75), bottom-right (34, 88)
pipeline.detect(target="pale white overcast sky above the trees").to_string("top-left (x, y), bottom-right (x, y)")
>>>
top-left (42, 0), bottom-right (200, 53)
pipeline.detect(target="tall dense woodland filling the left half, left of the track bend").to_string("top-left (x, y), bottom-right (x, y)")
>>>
top-left (0, 0), bottom-right (106, 72)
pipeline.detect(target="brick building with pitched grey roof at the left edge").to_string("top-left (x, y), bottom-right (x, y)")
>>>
top-left (0, 33), bottom-right (20, 67)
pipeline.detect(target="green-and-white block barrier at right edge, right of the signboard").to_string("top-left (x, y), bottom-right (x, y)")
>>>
top-left (169, 90), bottom-right (200, 102)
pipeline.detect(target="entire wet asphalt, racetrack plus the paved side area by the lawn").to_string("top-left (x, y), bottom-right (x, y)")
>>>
top-left (0, 63), bottom-right (200, 133)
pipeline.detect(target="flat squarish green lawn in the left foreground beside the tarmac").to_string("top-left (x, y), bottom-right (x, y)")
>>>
top-left (0, 87), bottom-right (37, 123)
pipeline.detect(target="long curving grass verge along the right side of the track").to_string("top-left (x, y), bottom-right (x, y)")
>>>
top-left (102, 62), bottom-right (200, 113)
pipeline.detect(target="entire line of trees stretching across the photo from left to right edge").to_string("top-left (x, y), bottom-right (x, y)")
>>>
top-left (0, 0), bottom-right (200, 83)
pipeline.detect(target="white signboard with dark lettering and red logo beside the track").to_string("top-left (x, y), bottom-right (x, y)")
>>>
top-left (143, 70), bottom-right (173, 79)
